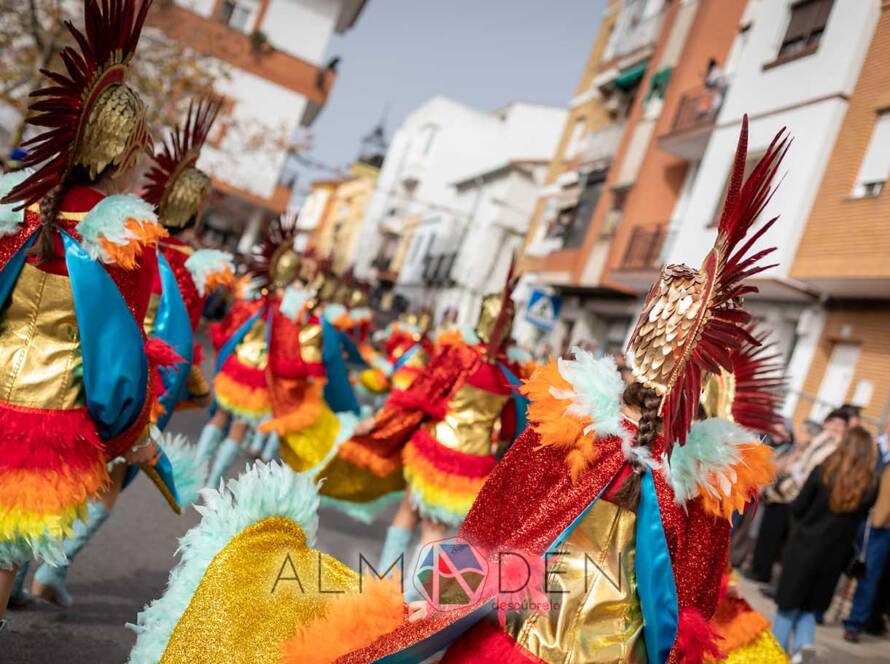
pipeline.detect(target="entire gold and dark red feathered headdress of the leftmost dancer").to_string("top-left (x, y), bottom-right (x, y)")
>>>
top-left (3, 0), bottom-right (151, 206)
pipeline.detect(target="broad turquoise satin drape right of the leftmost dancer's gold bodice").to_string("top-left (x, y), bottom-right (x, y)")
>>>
top-left (61, 233), bottom-right (148, 440)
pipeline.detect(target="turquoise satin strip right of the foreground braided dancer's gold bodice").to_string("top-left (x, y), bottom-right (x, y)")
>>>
top-left (635, 470), bottom-right (679, 664)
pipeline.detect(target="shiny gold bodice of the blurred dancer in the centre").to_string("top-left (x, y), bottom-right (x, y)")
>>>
top-left (427, 384), bottom-right (510, 456)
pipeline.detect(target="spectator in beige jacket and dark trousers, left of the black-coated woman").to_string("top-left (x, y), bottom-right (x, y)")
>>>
top-left (747, 410), bottom-right (847, 583)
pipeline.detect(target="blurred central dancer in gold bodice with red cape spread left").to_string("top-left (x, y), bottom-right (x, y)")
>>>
top-left (318, 277), bottom-right (525, 544)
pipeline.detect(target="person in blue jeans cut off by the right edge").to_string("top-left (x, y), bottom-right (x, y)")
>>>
top-left (844, 423), bottom-right (890, 643)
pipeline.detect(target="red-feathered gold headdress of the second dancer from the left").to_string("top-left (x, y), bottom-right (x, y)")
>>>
top-left (142, 98), bottom-right (222, 227)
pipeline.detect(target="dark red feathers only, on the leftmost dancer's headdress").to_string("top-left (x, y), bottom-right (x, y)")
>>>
top-left (2, 0), bottom-right (151, 207)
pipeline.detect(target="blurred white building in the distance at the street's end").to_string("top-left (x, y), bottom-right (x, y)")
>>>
top-left (357, 97), bottom-right (566, 324)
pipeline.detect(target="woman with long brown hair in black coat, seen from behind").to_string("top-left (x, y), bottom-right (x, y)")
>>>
top-left (773, 427), bottom-right (876, 664)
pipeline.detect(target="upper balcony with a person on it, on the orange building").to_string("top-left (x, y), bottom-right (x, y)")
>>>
top-left (658, 86), bottom-right (726, 162)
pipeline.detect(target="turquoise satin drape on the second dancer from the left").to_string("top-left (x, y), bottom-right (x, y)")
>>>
top-left (152, 252), bottom-right (195, 431)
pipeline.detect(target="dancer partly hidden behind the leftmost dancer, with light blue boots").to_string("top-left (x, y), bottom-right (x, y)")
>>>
top-left (20, 101), bottom-right (234, 607)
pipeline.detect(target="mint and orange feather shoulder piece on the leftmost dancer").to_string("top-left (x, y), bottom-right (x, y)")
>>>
top-left (77, 194), bottom-right (167, 270)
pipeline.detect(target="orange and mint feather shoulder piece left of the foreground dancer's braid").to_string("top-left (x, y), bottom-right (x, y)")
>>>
top-left (521, 348), bottom-right (625, 479)
